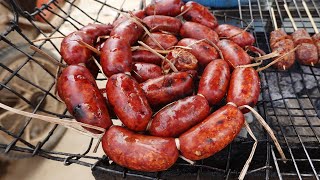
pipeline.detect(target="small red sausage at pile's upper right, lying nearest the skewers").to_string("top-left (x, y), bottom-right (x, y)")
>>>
top-left (215, 24), bottom-right (255, 48)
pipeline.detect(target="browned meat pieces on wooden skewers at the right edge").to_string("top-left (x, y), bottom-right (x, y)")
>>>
top-left (270, 29), bottom-right (320, 70)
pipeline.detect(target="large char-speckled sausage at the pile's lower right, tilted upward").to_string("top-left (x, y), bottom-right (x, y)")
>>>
top-left (179, 104), bottom-right (244, 160)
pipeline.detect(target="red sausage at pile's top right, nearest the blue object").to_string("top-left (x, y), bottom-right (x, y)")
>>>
top-left (181, 1), bottom-right (218, 29)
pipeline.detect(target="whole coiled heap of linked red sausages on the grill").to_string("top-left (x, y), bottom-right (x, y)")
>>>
top-left (57, 0), bottom-right (272, 172)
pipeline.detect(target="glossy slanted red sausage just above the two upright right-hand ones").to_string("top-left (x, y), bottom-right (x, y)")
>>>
top-left (217, 39), bottom-right (251, 69)
